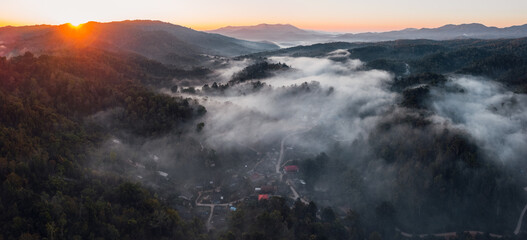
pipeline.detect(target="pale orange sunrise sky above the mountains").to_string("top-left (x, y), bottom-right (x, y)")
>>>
top-left (0, 0), bottom-right (527, 32)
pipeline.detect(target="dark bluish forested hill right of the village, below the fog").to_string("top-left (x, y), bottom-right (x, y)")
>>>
top-left (293, 113), bottom-right (524, 233)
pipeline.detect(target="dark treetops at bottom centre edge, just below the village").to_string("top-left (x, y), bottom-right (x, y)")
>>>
top-left (220, 197), bottom-right (350, 239)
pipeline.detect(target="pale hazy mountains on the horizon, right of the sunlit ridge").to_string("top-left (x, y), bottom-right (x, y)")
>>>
top-left (209, 23), bottom-right (527, 45)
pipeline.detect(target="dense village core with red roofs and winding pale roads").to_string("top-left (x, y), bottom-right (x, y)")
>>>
top-left (193, 142), bottom-right (308, 230)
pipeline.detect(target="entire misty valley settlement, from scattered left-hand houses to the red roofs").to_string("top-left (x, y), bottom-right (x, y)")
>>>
top-left (112, 126), bottom-right (338, 230)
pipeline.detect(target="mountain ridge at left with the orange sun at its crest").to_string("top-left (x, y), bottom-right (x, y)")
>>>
top-left (0, 20), bottom-right (279, 65)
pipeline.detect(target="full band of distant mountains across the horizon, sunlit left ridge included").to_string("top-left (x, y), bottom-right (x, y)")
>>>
top-left (4, 20), bottom-right (527, 64)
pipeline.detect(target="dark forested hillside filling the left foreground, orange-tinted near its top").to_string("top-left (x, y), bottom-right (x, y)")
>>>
top-left (0, 49), bottom-right (205, 239)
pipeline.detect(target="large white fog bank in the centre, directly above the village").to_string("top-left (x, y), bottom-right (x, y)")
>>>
top-left (198, 54), bottom-right (396, 150)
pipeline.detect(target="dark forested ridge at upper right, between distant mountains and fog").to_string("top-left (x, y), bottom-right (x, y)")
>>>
top-left (249, 38), bottom-right (527, 92)
